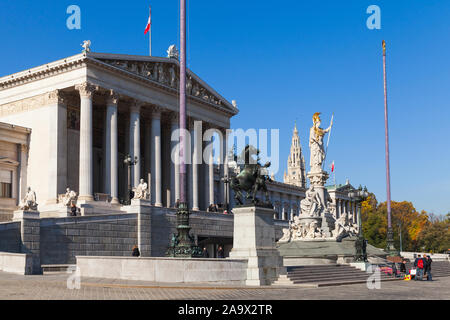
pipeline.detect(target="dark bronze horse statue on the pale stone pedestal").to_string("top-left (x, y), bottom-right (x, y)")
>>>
top-left (230, 145), bottom-right (272, 205)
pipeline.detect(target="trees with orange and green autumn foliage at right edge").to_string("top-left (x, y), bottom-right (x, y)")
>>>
top-left (361, 193), bottom-right (450, 252)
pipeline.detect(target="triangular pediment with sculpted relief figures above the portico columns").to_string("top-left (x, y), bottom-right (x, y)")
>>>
top-left (87, 53), bottom-right (238, 114)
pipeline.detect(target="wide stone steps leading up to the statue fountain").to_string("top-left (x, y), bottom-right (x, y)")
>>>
top-left (273, 264), bottom-right (401, 287)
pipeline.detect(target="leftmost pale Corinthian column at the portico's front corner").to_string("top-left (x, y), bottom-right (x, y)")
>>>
top-left (75, 82), bottom-right (96, 201)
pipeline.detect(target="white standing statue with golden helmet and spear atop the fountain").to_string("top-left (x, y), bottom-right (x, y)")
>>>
top-left (309, 112), bottom-right (333, 172)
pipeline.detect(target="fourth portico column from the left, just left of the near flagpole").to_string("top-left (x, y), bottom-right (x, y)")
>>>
top-left (151, 109), bottom-right (162, 207)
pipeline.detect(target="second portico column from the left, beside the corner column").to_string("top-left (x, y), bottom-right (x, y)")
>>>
top-left (105, 90), bottom-right (119, 203)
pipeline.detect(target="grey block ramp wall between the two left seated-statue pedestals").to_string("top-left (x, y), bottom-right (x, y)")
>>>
top-left (41, 214), bottom-right (137, 264)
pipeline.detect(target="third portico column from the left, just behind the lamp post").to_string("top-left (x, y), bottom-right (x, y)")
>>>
top-left (130, 101), bottom-right (142, 187)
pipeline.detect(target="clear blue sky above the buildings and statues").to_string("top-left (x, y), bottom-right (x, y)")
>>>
top-left (0, 0), bottom-right (450, 214)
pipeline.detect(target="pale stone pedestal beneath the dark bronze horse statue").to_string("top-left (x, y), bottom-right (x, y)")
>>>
top-left (230, 206), bottom-right (286, 286)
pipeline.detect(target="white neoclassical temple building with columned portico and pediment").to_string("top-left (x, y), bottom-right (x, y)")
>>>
top-left (0, 52), bottom-right (238, 211)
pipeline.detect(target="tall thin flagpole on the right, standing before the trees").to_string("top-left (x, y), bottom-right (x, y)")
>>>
top-left (382, 40), bottom-right (395, 254)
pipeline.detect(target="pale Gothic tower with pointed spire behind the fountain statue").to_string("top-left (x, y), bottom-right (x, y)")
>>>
top-left (284, 121), bottom-right (306, 188)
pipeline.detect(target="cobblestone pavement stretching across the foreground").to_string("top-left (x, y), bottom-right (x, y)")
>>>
top-left (0, 272), bottom-right (450, 300)
